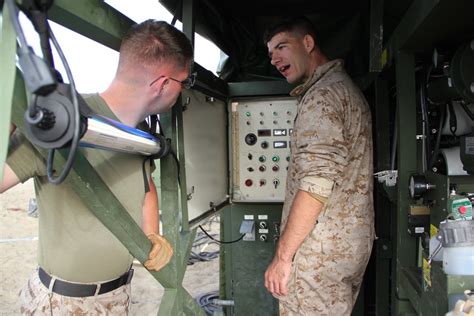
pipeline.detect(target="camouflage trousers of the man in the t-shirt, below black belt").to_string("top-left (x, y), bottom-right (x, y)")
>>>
top-left (19, 271), bottom-right (131, 316)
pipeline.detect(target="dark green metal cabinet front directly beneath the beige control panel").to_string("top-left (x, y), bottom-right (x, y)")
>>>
top-left (221, 204), bottom-right (282, 316)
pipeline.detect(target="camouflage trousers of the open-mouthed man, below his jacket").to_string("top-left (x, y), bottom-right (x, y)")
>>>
top-left (279, 233), bottom-right (372, 316)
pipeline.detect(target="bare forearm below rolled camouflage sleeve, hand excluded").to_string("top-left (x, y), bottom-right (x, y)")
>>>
top-left (275, 191), bottom-right (323, 261)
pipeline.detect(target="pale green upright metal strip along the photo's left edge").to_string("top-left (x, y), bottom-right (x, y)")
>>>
top-left (0, 8), bottom-right (16, 180)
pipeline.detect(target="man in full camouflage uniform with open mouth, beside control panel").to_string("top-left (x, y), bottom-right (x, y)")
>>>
top-left (265, 18), bottom-right (374, 315)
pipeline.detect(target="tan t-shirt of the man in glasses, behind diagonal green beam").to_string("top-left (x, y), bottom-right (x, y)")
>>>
top-left (7, 94), bottom-right (150, 283)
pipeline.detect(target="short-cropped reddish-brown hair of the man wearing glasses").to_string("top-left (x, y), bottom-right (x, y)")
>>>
top-left (119, 19), bottom-right (193, 68)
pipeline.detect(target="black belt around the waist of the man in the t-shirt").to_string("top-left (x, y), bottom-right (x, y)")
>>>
top-left (38, 267), bottom-right (133, 297)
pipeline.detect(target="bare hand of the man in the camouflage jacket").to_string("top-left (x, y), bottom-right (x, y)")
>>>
top-left (265, 257), bottom-right (291, 296)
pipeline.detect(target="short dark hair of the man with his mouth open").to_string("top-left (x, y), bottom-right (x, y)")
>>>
top-left (263, 16), bottom-right (316, 45)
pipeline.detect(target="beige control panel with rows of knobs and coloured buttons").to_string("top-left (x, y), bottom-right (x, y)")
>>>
top-left (231, 97), bottom-right (296, 202)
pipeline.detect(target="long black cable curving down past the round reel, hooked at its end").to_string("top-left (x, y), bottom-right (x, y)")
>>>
top-left (47, 25), bottom-right (81, 184)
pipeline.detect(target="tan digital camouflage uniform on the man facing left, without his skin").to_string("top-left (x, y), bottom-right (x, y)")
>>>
top-left (280, 60), bottom-right (374, 315)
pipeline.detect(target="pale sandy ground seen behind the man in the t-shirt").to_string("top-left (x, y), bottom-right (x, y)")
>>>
top-left (0, 181), bottom-right (219, 316)
